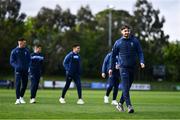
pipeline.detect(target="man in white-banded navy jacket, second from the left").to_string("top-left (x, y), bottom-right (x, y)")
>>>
top-left (30, 45), bottom-right (44, 103)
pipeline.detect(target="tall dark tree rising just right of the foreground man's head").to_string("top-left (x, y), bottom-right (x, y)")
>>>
top-left (131, 0), bottom-right (169, 64)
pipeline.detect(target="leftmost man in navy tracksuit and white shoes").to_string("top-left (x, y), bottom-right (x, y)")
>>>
top-left (10, 38), bottom-right (30, 105)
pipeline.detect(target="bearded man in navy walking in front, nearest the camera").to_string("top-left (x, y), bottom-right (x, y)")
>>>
top-left (109, 25), bottom-right (145, 113)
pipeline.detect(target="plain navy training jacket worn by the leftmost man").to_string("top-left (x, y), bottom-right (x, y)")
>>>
top-left (10, 47), bottom-right (30, 71)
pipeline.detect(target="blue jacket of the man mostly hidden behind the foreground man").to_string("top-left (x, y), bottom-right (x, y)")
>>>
top-left (102, 52), bottom-right (119, 74)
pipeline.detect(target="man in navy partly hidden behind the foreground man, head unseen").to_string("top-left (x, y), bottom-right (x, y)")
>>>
top-left (102, 52), bottom-right (119, 105)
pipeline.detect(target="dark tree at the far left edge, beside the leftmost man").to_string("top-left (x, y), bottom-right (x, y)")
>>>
top-left (0, 0), bottom-right (26, 71)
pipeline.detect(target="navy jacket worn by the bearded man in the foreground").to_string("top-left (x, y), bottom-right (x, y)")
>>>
top-left (111, 36), bottom-right (144, 68)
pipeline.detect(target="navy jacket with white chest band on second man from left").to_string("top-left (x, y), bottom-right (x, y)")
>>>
top-left (30, 53), bottom-right (44, 73)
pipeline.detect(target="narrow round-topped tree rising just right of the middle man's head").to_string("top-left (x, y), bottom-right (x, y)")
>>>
top-left (76, 6), bottom-right (103, 77)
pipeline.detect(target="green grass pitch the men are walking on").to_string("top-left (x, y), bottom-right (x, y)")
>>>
top-left (0, 89), bottom-right (180, 119)
